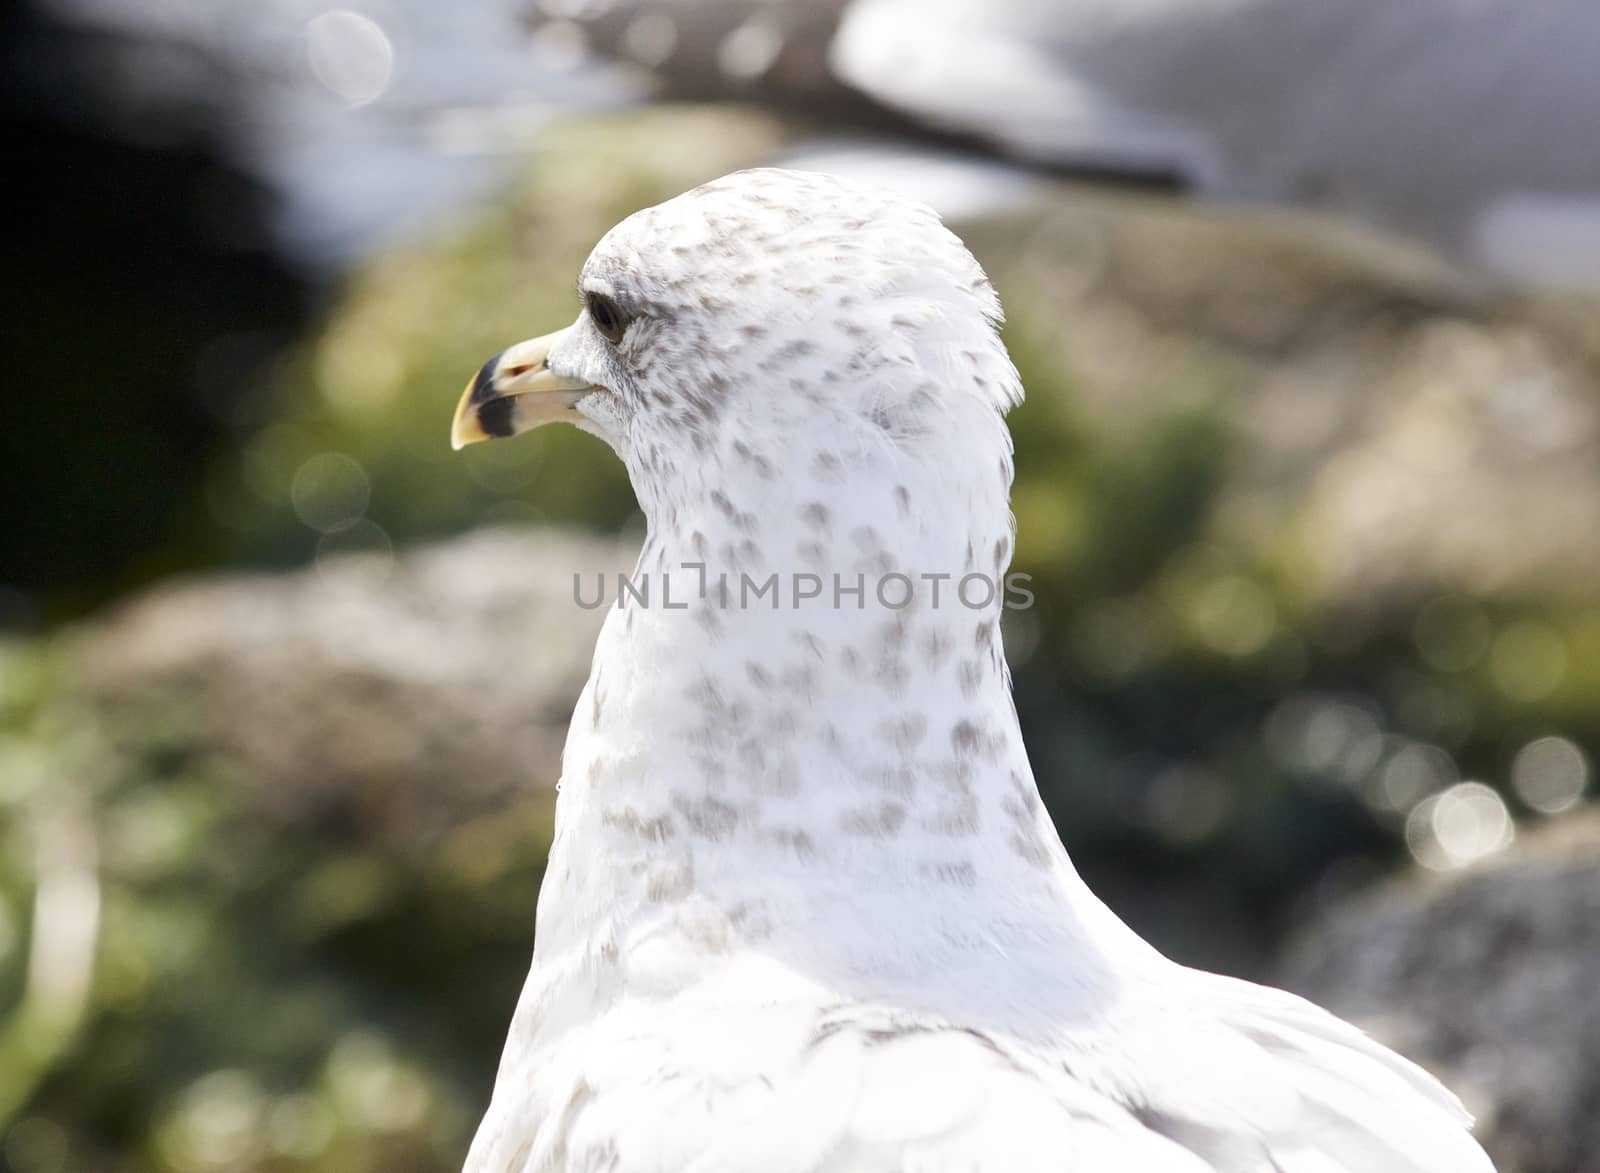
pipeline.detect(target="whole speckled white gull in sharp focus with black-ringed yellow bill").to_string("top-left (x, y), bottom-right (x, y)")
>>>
top-left (451, 170), bottom-right (1491, 1173)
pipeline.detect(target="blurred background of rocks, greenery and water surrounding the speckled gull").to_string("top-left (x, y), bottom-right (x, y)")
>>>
top-left (0, 0), bottom-right (1600, 1173)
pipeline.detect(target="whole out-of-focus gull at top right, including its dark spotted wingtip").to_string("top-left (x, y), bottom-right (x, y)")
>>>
top-left (536, 0), bottom-right (1600, 293)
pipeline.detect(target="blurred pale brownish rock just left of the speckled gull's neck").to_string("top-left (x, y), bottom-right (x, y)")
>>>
top-left (67, 528), bottom-right (632, 847)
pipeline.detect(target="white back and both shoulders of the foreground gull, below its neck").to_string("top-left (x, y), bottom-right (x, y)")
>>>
top-left (467, 965), bottom-right (1491, 1173)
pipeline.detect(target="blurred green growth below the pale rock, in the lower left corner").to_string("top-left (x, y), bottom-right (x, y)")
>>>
top-left (0, 650), bottom-right (550, 1173)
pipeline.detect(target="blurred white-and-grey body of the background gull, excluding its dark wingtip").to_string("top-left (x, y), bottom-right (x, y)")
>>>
top-left (829, 0), bottom-right (1600, 291)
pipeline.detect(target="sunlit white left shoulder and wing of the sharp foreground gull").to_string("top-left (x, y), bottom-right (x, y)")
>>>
top-left (467, 985), bottom-right (1211, 1173)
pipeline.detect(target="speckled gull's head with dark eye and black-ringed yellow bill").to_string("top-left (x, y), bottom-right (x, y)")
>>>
top-left (451, 170), bottom-right (1021, 496)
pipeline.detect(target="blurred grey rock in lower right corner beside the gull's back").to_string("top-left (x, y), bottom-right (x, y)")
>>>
top-left (1282, 810), bottom-right (1600, 1173)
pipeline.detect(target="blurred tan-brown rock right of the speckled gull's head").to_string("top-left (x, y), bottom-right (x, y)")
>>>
top-left (963, 187), bottom-right (1600, 608)
